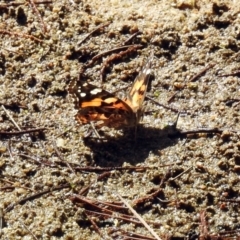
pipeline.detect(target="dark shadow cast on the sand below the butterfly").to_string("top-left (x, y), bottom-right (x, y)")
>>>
top-left (84, 125), bottom-right (180, 167)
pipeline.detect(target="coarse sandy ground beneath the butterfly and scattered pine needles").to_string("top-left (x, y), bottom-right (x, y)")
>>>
top-left (0, 0), bottom-right (240, 240)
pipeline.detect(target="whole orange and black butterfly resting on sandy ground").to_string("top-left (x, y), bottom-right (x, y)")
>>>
top-left (69, 54), bottom-right (153, 129)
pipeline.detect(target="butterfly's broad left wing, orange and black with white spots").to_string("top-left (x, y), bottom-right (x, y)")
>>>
top-left (69, 82), bottom-right (135, 128)
